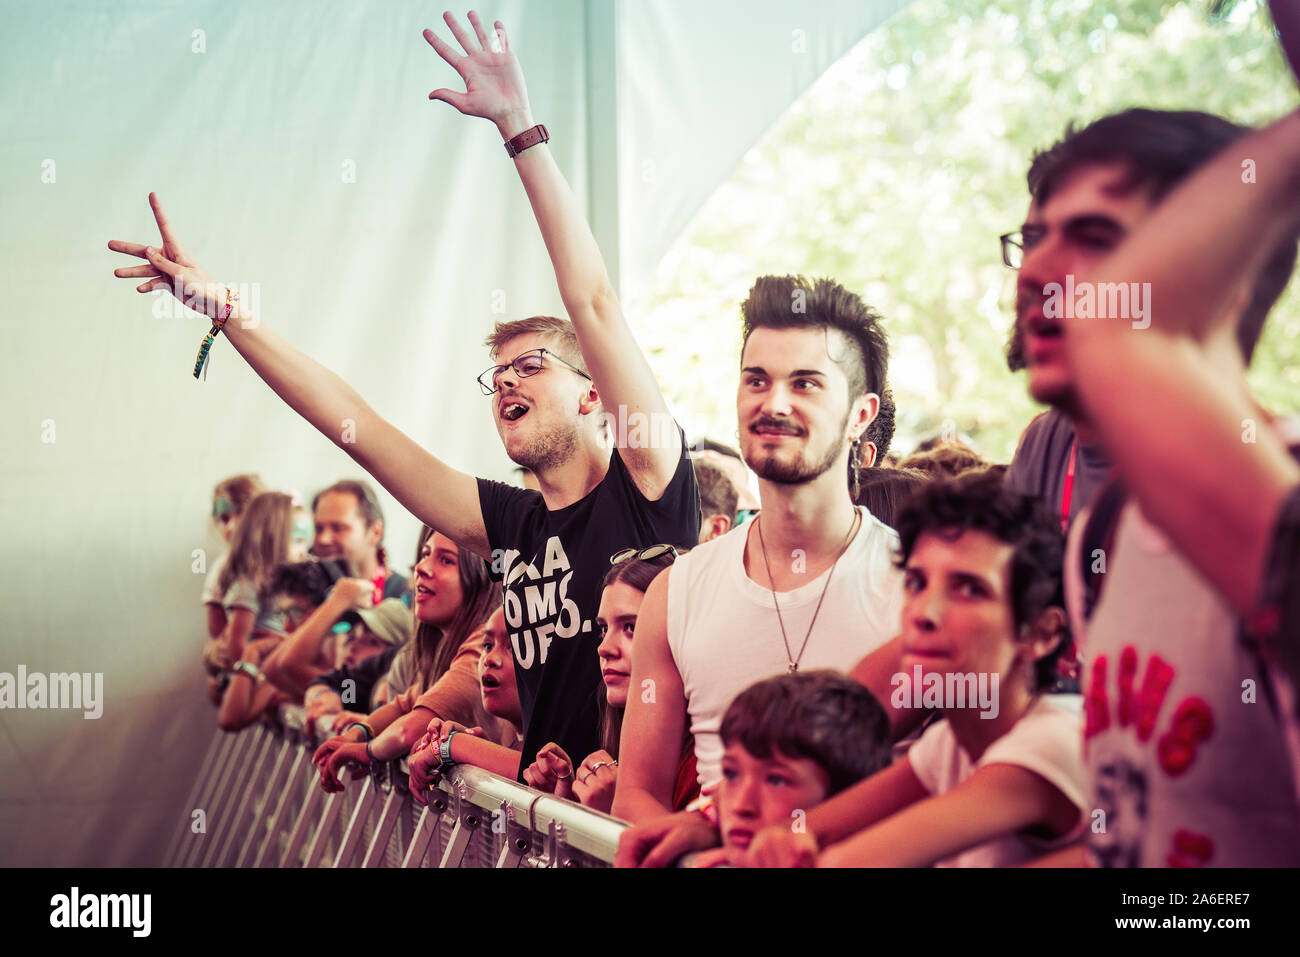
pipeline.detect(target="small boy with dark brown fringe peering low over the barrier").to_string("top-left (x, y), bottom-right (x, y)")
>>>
top-left (694, 671), bottom-right (891, 867)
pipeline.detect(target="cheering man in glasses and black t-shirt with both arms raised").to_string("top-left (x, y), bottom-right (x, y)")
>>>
top-left (109, 13), bottom-right (699, 780)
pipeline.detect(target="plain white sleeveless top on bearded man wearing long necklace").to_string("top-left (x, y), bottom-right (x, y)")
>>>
top-left (668, 507), bottom-right (902, 787)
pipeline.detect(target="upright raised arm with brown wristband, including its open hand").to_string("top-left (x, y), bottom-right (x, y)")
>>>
top-left (424, 12), bottom-right (681, 501)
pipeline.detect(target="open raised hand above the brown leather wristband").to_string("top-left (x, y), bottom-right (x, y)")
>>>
top-left (424, 10), bottom-right (532, 137)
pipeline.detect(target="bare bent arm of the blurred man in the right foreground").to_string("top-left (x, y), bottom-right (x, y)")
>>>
top-left (1069, 106), bottom-right (1300, 612)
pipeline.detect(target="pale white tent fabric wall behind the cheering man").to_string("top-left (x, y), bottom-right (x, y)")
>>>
top-left (0, 0), bottom-right (900, 866)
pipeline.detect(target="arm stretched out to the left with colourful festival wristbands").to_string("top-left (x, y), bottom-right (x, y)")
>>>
top-left (108, 192), bottom-right (490, 558)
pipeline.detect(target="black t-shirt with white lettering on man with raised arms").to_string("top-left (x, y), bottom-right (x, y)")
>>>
top-left (478, 441), bottom-right (699, 768)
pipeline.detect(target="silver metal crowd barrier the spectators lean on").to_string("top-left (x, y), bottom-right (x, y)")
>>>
top-left (164, 706), bottom-right (627, 867)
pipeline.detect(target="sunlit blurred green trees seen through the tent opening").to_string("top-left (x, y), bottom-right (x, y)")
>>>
top-left (638, 0), bottom-right (1300, 462)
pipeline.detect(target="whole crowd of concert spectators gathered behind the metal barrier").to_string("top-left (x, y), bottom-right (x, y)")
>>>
top-left (111, 13), bottom-right (1300, 866)
